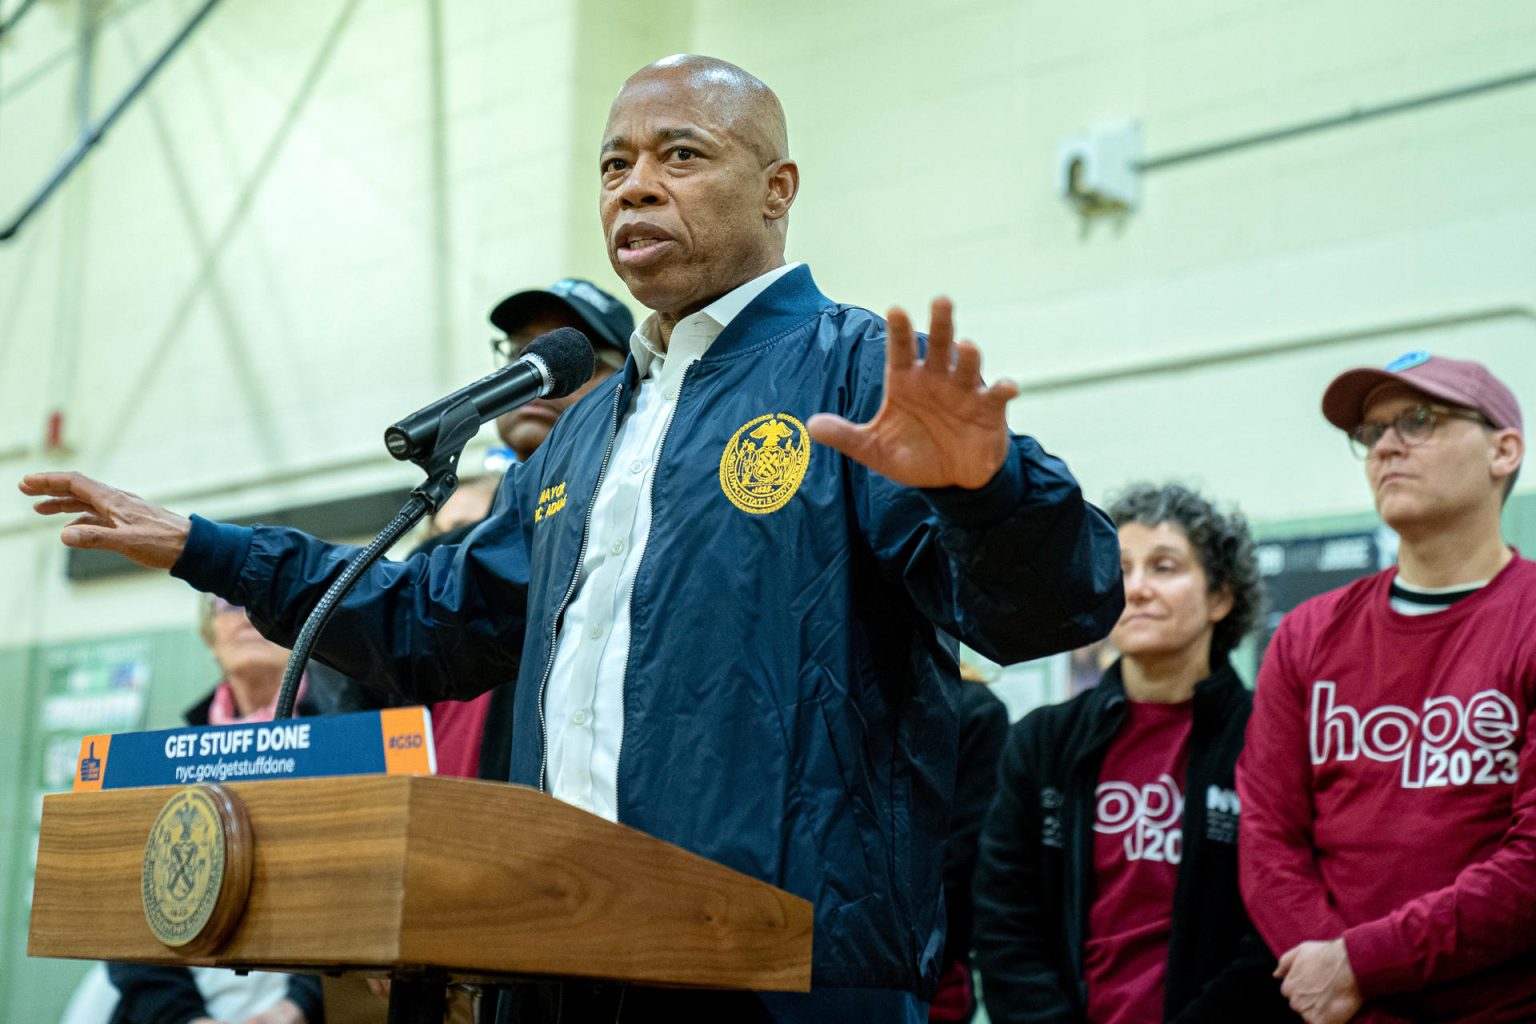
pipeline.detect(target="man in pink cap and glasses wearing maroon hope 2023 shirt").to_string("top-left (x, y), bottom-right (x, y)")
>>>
top-left (1238, 352), bottom-right (1536, 1024)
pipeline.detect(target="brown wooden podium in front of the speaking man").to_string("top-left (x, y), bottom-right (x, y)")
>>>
top-left (28, 775), bottom-right (811, 1019)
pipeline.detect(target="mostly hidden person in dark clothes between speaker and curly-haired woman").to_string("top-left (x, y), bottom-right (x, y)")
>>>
top-left (928, 662), bottom-right (1008, 1022)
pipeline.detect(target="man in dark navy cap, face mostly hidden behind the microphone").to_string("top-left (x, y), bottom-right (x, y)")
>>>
top-left (490, 278), bottom-right (634, 462)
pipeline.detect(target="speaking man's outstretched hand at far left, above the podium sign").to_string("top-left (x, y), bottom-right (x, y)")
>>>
top-left (20, 473), bottom-right (192, 570)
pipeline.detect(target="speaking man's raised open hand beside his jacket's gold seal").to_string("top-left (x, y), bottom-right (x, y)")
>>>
top-left (806, 298), bottom-right (1018, 488)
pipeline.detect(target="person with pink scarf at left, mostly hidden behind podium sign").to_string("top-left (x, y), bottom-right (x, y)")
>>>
top-left (108, 594), bottom-right (326, 1024)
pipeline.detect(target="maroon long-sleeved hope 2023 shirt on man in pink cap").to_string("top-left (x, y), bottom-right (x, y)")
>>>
top-left (1238, 557), bottom-right (1536, 1021)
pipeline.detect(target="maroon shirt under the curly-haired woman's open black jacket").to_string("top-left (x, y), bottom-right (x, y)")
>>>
top-left (1083, 700), bottom-right (1193, 1024)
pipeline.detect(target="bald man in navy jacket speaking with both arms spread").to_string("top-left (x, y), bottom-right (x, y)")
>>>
top-left (22, 57), bottom-right (1123, 1021)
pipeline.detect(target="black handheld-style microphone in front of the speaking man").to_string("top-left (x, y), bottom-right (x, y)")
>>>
top-left (384, 327), bottom-right (596, 462)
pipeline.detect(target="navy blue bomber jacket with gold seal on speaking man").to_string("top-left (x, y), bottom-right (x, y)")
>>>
top-left (174, 267), bottom-right (1123, 992)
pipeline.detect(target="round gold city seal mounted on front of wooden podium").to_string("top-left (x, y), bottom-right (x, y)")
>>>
top-left (143, 783), bottom-right (250, 955)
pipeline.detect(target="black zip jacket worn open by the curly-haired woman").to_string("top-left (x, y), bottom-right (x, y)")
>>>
top-left (975, 662), bottom-right (1298, 1024)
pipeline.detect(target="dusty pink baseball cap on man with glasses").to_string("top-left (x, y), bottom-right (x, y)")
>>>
top-left (1322, 350), bottom-right (1524, 431)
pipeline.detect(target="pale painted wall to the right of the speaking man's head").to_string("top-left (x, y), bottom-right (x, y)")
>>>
top-left (697, 0), bottom-right (1536, 520)
